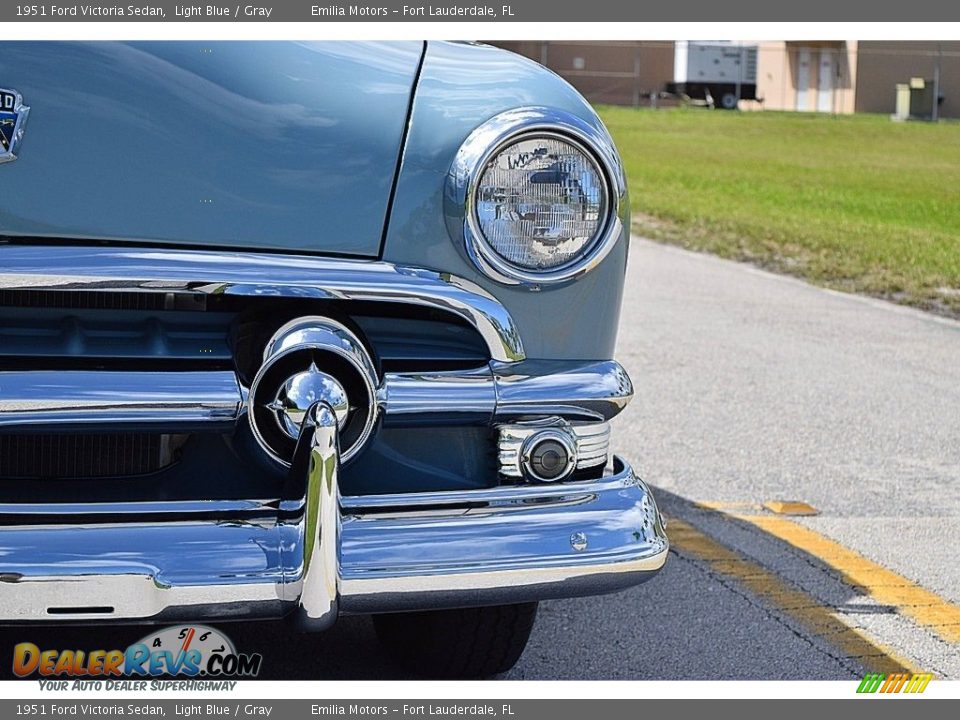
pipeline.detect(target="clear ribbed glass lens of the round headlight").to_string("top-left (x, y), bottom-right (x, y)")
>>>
top-left (474, 135), bottom-right (609, 271)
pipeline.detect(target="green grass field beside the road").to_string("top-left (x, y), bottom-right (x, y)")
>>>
top-left (599, 107), bottom-right (960, 315)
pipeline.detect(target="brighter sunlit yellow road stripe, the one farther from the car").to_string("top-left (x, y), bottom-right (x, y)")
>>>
top-left (732, 514), bottom-right (960, 643)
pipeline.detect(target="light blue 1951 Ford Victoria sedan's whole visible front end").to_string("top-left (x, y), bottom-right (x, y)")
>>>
top-left (0, 42), bottom-right (668, 677)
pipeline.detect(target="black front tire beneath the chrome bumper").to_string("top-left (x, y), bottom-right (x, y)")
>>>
top-left (373, 603), bottom-right (537, 679)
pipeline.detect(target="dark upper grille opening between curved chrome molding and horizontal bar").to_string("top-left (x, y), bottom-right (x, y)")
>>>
top-left (0, 289), bottom-right (490, 374)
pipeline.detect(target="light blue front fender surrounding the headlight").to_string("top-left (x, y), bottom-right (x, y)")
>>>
top-left (383, 42), bottom-right (629, 360)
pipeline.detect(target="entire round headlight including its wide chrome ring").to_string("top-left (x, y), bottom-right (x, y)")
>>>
top-left (447, 108), bottom-right (627, 287)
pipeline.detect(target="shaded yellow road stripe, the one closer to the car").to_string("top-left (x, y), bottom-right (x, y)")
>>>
top-left (669, 517), bottom-right (917, 673)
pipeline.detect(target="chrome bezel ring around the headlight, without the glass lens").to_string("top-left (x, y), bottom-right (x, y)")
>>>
top-left (448, 107), bottom-right (628, 287)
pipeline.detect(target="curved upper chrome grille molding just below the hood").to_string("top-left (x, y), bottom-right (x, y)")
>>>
top-left (0, 245), bottom-right (524, 362)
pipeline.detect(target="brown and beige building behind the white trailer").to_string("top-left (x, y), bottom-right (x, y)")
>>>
top-left (494, 40), bottom-right (960, 118)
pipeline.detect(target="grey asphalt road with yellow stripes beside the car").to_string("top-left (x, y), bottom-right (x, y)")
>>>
top-left (0, 239), bottom-right (960, 680)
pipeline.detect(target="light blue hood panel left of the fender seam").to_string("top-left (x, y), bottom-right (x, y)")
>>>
top-left (0, 42), bottom-right (423, 256)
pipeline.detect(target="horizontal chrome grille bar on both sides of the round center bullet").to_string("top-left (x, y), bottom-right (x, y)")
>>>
top-left (0, 360), bottom-right (633, 434)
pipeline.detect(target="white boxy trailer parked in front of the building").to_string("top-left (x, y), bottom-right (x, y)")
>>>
top-left (666, 41), bottom-right (757, 110)
